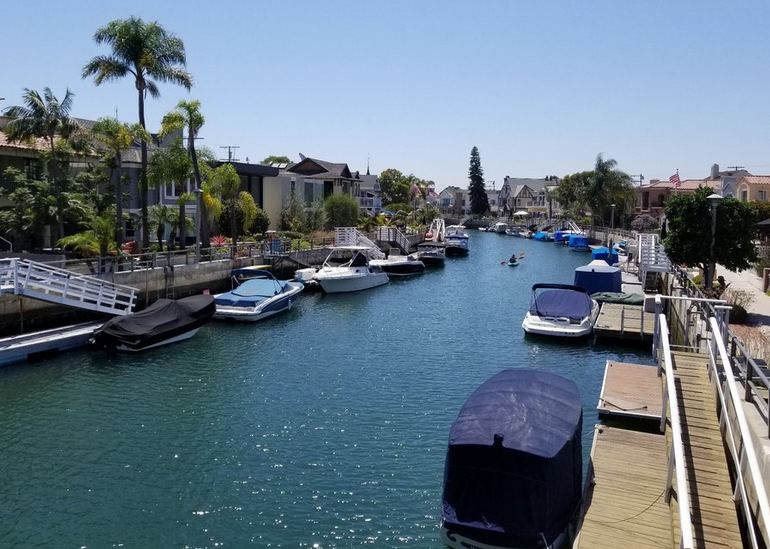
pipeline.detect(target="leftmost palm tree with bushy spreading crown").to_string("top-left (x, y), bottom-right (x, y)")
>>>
top-left (4, 88), bottom-right (79, 238)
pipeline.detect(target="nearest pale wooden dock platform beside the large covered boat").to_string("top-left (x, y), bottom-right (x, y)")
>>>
top-left (574, 425), bottom-right (673, 549)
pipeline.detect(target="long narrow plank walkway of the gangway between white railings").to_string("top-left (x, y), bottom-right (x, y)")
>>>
top-left (671, 352), bottom-right (743, 547)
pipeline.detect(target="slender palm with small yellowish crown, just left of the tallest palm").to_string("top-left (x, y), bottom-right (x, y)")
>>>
top-left (91, 117), bottom-right (149, 248)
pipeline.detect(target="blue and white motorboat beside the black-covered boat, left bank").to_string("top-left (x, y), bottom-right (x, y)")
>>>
top-left (214, 268), bottom-right (304, 322)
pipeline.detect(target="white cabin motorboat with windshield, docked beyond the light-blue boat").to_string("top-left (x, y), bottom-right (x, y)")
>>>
top-left (313, 246), bottom-right (389, 294)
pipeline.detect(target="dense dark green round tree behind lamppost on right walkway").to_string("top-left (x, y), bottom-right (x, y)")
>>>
top-left (663, 186), bottom-right (757, 286)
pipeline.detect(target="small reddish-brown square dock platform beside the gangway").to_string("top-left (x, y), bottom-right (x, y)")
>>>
top-left (596, 360), bottom-right (663, 423)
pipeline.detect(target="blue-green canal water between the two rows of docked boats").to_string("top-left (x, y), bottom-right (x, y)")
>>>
top-left (0, 231), bottom-right (649, 548)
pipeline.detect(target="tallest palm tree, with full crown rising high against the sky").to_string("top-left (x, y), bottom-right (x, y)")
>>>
top-left (83, 17), bottom-right (192, 247)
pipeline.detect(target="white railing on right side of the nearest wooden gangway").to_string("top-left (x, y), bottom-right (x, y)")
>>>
top-left (709, 316), bottom-right (770, 549)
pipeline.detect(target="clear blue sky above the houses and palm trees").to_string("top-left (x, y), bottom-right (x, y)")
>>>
top-left (0, 0), bottom-right (770, 188)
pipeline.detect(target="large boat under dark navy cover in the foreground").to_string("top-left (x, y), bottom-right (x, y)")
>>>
top-left (440, 368), bottom-right (583, 549)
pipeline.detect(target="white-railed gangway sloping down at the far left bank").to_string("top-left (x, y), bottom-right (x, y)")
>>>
top-left (0, 258), bottom-right (138, 315)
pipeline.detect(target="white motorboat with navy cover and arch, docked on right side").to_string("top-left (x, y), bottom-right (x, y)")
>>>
top-left (521, 284), bottom-right (599, 337)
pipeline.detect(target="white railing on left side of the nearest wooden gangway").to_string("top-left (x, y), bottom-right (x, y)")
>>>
top-left (653, 310), bottom-right (695, 549)
